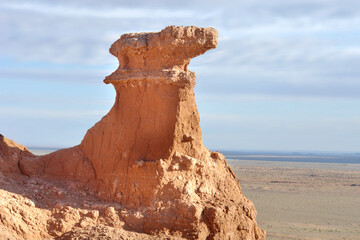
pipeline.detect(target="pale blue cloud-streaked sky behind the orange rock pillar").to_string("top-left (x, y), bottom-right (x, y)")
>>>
top-left (0, 0), bottom-right (360, 152)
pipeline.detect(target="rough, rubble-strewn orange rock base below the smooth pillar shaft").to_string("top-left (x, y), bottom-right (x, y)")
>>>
top-left (0, 136), bottom-right (264, 239)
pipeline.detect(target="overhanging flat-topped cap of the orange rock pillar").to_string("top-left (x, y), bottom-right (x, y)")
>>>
top-left (105, 26), bottom-right (218, 82)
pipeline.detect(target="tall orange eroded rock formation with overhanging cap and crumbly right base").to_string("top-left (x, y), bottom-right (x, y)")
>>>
top-left (14, 26), bottom-right (265, 239)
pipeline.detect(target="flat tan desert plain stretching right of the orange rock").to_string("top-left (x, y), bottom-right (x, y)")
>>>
top-left (228, 160), bottom-right (360, 240)
